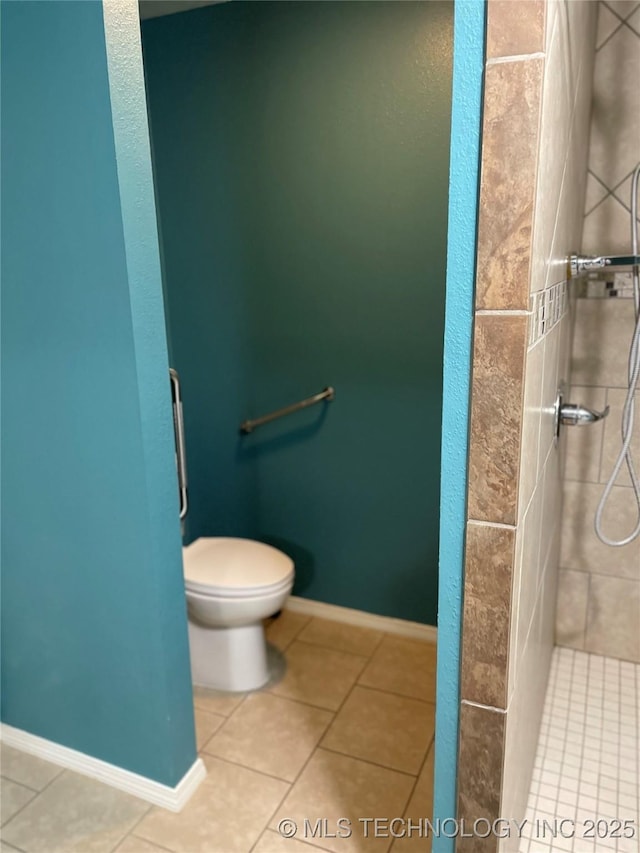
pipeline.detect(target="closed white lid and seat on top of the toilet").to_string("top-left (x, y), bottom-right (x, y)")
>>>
top-left (182, 536), bottom-right (293, 588)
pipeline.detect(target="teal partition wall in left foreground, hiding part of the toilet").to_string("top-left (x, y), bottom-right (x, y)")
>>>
top-left (1, 2), bottom-right (196, 786)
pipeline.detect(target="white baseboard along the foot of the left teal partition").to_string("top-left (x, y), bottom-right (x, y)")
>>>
top-left (0, 723), bottom-right (207, 812)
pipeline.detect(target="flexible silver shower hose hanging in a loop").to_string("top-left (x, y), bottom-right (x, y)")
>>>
top-left (594, 163), bottom-right (640, 548)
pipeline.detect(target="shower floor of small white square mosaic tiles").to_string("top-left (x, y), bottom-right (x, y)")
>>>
top-left (520, 648), bottom-right (640, 853)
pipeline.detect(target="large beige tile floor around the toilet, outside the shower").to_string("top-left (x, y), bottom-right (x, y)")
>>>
top-left (0, 611), bottom-right (436, 853)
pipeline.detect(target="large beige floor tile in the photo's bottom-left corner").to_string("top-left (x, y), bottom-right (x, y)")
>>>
top-left (2, 770), bottom-right (149, 853)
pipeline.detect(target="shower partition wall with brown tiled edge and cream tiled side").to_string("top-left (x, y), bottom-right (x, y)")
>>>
top-left (457, 0), bottom-right (597, 853)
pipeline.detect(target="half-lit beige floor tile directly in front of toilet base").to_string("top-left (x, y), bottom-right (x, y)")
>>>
top-left (205, 693), bottom-right (333, 782)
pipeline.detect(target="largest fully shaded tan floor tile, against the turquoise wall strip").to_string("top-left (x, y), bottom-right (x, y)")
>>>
top-left (322, 686), bottom-right (435, 774)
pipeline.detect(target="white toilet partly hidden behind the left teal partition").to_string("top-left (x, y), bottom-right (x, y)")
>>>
top-left (182, 536), bottom-right (294, 691)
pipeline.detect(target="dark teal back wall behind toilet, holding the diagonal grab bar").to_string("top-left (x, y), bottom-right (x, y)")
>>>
top-left (143, 2), bottom-right (453, 623)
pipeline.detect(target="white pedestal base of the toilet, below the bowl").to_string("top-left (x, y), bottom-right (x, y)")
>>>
top-left (189, 619), bottom-right (269, 691)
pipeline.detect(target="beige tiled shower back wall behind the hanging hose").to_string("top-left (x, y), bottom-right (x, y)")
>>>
top-left (556, 0), bottom-right (640, 661)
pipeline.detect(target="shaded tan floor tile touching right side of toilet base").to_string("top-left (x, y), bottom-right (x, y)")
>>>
top-left (270, 640), bottom-right (367, 711)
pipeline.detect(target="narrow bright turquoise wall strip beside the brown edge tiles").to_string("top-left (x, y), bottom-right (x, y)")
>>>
top-left (433, 0), bottom-right (486, 853)
